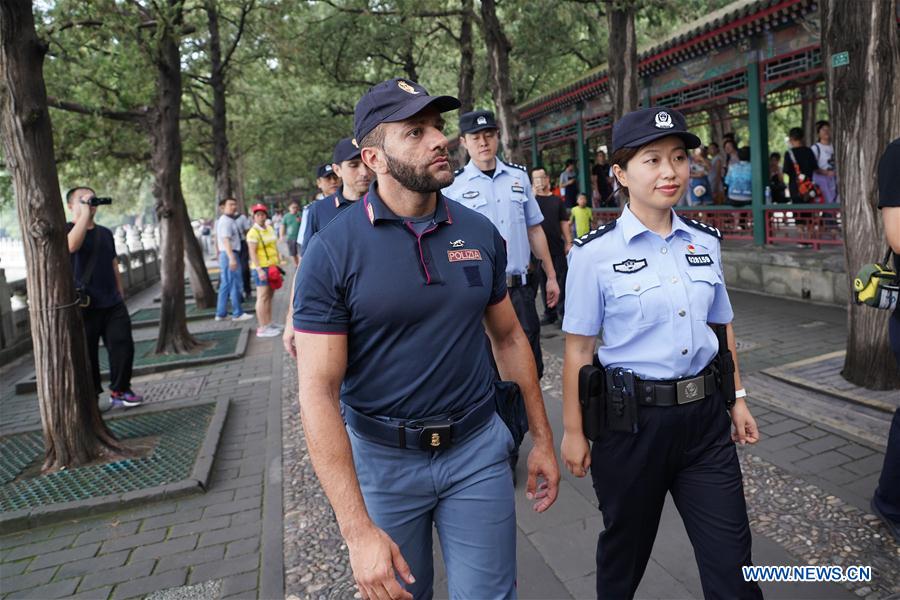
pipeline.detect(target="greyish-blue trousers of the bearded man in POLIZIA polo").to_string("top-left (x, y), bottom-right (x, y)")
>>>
top-left (348, 415), bottom-right (516, 600)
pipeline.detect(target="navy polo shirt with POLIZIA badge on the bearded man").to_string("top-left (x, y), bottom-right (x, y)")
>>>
top-left (293, 183), bottom-right (506, 419)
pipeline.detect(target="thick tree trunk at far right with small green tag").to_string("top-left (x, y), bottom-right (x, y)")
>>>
top-left (821, 0), bottom-right (900, 390)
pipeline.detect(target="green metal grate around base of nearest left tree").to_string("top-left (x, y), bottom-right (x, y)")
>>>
top-left (0, 403), bottom-right (215, 512)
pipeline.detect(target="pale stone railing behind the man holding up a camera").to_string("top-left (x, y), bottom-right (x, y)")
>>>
top-left (0, 244), bottom-right (160, 365)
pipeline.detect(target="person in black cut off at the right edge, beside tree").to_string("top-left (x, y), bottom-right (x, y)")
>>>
top-left (872, 138), bottom-right (900, 542)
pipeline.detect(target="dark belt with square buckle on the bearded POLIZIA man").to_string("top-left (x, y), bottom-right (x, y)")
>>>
top-left (343, 394), bottom-right (496, 450)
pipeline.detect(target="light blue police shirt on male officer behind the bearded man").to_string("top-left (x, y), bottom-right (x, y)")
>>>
top-left (441, 158), bottom-right (544, 275)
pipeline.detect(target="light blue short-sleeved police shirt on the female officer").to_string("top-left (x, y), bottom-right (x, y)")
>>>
top-left (563, 206), bottom-right (734, 379)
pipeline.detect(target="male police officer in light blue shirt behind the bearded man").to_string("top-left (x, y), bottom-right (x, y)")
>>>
top-left (444, 110), bottom-right (559, 377)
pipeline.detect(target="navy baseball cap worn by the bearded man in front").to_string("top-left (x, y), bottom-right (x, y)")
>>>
top-left (353, 77), bottom-right (460, 146)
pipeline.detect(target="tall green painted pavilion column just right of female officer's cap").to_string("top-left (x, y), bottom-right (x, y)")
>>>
top-left (747, 62), bottom-right (769, 246)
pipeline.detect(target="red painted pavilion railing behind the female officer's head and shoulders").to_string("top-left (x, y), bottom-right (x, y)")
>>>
top-left (593, 205), bottom-right (844, 250)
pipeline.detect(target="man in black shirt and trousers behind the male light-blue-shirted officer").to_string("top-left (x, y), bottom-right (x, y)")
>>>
top-left (531, 169), bottom-right (572, 325)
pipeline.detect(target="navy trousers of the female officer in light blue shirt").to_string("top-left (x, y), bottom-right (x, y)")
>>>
top-left (591, 394), bottom-right (762, 599)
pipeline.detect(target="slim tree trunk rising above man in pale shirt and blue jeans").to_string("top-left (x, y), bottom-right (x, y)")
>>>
top-left (205, 0), bottom-right (234, 206)
